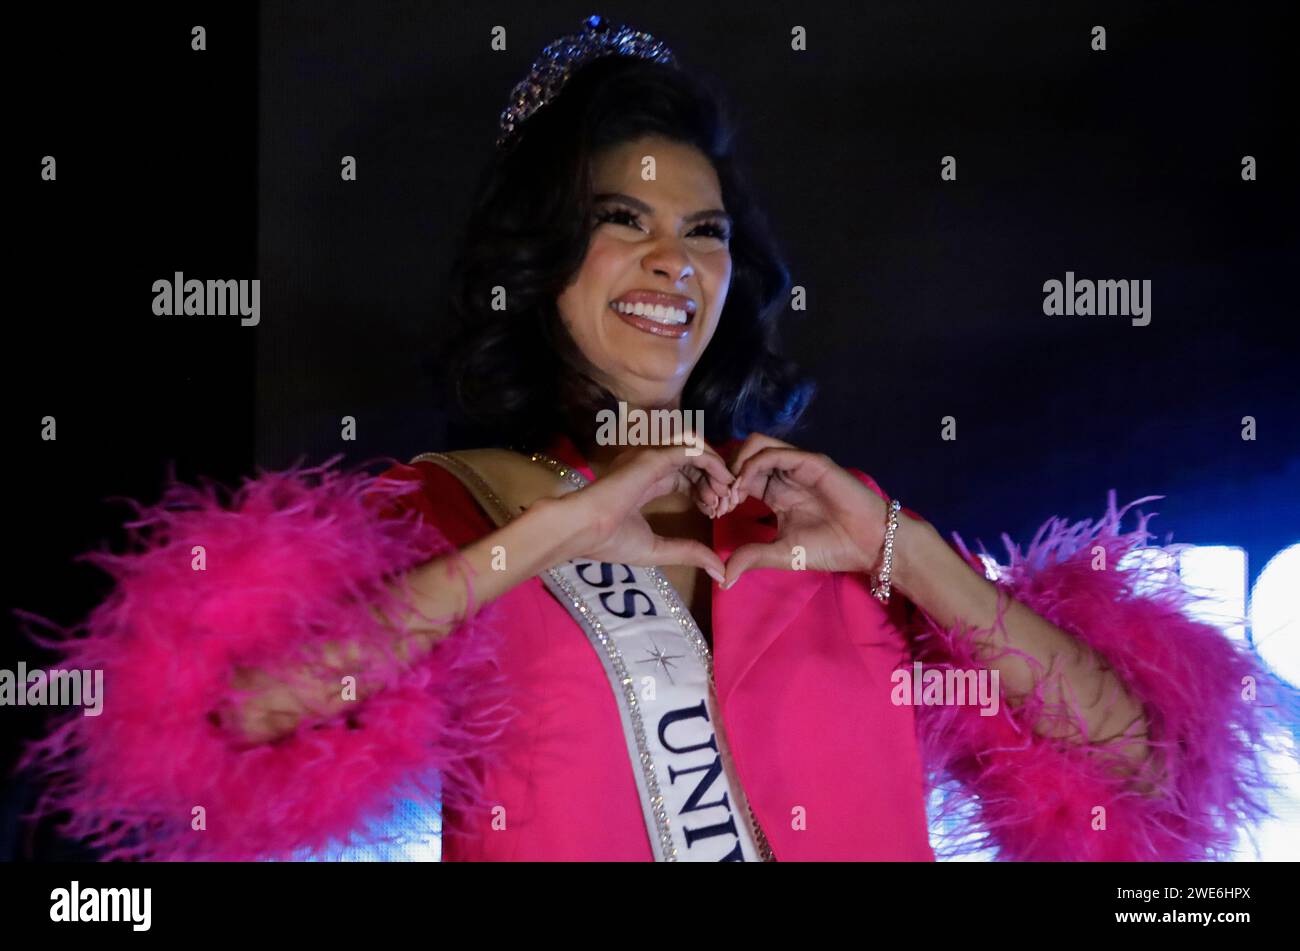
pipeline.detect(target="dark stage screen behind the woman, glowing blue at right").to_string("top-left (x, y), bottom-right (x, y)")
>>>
top-left (256, 3), bottom-right (1300, 568)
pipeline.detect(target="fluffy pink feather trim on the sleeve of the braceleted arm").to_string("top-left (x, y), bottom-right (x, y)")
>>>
top-left (911, 492), bottom-right (1290, 861)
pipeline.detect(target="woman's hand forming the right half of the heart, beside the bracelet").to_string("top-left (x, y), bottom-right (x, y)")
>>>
top-left (723, 433), bottom-right (897, 587)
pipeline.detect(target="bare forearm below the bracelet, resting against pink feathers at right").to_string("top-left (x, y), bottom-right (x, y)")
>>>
top-left (893, 517), bottom-right (1147, 761)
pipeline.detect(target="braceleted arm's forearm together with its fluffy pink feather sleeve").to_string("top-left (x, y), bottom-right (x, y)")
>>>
top-left (854, 470), bottom-right (1282, 861)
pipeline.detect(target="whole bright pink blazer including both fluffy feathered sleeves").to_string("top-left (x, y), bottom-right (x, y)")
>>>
top-left (32, 426), bottom-right (1294, 861)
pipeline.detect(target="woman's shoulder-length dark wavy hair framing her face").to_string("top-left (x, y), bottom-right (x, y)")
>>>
top-left (442, 57), bottom-right (815, 450)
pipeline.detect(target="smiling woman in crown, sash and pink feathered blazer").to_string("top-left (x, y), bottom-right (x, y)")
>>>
top-left (25, 18), bottom-right (1284, 860)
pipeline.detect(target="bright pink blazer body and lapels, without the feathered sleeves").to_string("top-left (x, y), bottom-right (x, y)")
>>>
top-left (387, 438), bottom-right (933, 861)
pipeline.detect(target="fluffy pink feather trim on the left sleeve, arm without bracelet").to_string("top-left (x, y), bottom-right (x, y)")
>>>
top-left (16, 457), bottom-right (512, 860)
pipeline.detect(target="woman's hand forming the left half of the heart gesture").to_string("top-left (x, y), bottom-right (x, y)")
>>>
top-left (556, 446), bottom-right (736, 583)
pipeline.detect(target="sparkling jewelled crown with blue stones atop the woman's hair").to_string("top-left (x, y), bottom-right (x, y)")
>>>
top-left (497, 16), bottom-right (677, 149)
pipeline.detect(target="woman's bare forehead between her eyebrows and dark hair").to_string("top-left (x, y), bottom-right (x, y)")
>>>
top-left (592, 136), bottom-right (722, 203)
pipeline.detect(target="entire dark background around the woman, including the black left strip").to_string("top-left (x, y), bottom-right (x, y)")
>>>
top-left (0, 3), bottom-right (1300, 859)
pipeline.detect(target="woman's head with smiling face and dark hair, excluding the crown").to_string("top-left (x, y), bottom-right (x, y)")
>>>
top-left (446, 46), bottom-right (814, 447)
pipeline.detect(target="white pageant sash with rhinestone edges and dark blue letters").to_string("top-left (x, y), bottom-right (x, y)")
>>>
top-left (411, 452), bottom-right (774, 861)
